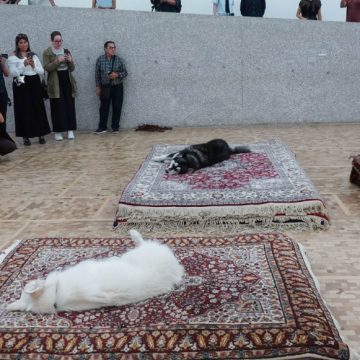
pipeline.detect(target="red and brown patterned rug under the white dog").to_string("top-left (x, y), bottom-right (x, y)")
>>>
top-left (0, 233), bottom-right (349, 360)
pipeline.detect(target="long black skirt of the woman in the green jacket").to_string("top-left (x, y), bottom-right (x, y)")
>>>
top-left (50, 71), bottom-right (76, 132)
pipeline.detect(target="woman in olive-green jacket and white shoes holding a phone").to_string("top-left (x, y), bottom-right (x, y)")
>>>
top-left (43, 31), bottom-right (77, 141)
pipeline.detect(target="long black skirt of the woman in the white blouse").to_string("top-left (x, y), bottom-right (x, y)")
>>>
top-left (13, 75), bottom-right (51, 138)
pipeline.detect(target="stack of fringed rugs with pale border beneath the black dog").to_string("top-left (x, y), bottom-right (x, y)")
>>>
top-left (114, 140), bottom-right (329, 235)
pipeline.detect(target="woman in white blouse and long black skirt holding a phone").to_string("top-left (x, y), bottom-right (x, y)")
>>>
top-left (8, 34), bottom-right (51, 146)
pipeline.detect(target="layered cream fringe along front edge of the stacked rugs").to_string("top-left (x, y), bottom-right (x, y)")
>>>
top-left (115, 200), bottom-right (330, 235)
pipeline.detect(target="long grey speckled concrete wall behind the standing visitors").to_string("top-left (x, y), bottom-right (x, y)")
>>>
top-left (0, 5), bottom-right (360, 130)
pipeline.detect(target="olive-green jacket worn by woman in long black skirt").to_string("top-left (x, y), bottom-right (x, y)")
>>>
top-left (43, 47), bottom-right (77, 99)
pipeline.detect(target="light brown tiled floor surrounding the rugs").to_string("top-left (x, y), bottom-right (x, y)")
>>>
top-left (0, 123), bottom-right (360, 352)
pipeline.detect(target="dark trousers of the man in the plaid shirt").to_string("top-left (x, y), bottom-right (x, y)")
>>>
top-left (98, 83), bottom-right (124, 130)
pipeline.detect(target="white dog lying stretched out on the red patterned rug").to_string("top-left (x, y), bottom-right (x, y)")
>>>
top-left (7, 230), bottom-right (184, 314)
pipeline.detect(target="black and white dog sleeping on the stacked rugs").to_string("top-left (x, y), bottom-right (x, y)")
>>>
top-left (153, 139), bottom-right (251, 174)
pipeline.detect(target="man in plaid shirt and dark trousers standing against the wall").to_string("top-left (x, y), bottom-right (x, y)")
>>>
top-left (95, 41), bottom-right (127, 134)
